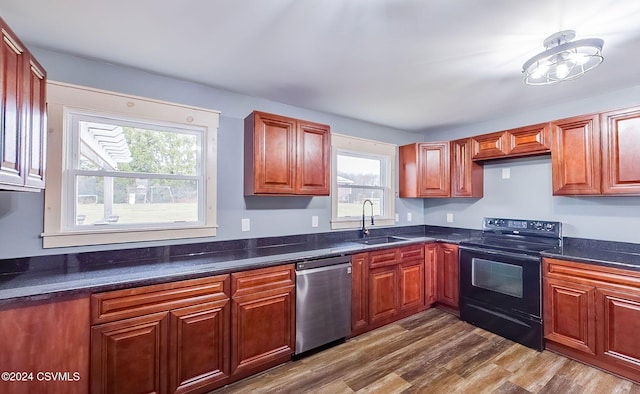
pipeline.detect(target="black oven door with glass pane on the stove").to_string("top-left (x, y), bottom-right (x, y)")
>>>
top-left (460, 246), bottom-right (542, 319)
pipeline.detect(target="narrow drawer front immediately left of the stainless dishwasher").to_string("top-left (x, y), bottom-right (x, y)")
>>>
top-left (231, 264), bottom-right (295, 297)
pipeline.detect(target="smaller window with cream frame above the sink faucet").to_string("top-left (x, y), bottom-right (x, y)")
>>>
top-left (331, 134), bottom-right (396, 229)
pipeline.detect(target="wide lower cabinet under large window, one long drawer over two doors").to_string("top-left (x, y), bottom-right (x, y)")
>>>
top-left (91, 275), bottom-right (231, 393)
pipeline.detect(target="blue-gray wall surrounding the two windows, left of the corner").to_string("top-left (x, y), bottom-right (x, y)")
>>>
top-left (0, 48), bottom-right (424, 258)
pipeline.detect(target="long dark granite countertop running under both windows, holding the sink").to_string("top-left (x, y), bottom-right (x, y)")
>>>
top-left (0, 231), bottom-right (470, 305)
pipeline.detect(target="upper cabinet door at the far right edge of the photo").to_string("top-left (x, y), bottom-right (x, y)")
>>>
top-left (602, 107), bottom-right (640, 194)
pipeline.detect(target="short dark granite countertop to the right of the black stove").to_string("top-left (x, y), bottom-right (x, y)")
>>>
top-left (542, 237), bottom-right (640, 271)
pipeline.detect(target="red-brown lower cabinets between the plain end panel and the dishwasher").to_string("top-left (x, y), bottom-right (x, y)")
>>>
top-left (87, 265), bottom-right (295, 394)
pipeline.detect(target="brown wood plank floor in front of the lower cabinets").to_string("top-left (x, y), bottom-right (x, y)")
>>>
top-left (214, 309), bottom-right (640, 394)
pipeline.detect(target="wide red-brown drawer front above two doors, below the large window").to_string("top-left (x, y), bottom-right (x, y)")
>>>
top-left (91, 275), bottom-right (229, 324)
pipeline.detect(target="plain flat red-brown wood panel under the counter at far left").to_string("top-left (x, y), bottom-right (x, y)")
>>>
top-left (0, 296), bottom-right (90, 394)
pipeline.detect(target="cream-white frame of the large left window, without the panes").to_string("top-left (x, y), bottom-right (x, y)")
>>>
top-left (42, 81), bottom-right (220, 248)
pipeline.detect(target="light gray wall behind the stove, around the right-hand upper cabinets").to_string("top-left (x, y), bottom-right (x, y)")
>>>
top-left (424, 87), bottom-right (640, 243)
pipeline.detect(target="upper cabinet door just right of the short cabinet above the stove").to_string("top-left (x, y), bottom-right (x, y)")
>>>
top-left (551, 115), bottom-right (600, 196)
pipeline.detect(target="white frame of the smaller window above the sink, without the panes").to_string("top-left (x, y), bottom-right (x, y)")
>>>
top-left (331, 133), bottom-right (398, 230)
